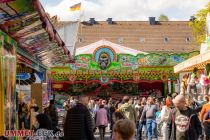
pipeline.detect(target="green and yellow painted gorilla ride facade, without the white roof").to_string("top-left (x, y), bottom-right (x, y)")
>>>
top-left (50, 43), bottom-right (199, 95)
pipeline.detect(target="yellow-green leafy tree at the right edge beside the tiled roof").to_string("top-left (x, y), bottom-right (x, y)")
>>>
top-left (189, 2), bottom-right (210, 45)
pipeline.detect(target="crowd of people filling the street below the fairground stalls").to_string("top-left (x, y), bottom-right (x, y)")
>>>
top-left (18, 88), bottom-right (210, 140)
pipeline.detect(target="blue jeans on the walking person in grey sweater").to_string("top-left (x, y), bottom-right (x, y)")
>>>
top-left (146, 119), bottom-right (158, 140)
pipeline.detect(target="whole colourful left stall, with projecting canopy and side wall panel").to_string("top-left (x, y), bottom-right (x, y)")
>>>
top-left (0, 0), bottom-right (72, 136)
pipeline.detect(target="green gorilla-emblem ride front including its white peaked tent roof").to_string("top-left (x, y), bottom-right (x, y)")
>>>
top-left (50, 40), bottom-right (198, 97)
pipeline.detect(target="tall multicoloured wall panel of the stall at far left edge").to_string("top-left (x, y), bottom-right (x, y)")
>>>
top-left (0, 30), bottom-right (18, 135)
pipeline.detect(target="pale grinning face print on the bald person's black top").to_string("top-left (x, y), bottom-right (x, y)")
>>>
top-left (175, 115), bottom-right (189, 132)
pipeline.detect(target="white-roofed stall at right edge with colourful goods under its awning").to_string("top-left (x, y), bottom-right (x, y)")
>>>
top-left (174, 13), bottom-right (210, 94)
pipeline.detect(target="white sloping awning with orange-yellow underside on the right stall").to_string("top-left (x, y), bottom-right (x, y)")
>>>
top-left (174, 50), bottom-right (210, 73)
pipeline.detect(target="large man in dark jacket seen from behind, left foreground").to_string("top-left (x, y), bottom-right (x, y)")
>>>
top-left (64, 96), bottom-right (95, 140)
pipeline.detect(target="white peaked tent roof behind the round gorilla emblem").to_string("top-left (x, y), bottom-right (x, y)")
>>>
top-left (76, 40), bottom-right (148, 55)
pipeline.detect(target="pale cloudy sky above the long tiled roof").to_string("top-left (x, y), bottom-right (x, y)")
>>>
top-left (41, 0), bottom-right (210, 21)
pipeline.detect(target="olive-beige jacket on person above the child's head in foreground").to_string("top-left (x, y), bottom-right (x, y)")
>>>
top-left (119, 103), bottom-right (136, 122)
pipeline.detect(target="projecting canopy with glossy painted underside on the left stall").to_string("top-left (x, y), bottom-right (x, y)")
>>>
top-left (0, 0), bottom-right (72, 67)
